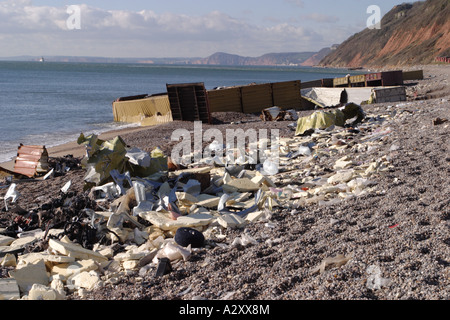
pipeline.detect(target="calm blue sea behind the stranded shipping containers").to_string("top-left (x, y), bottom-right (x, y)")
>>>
top-left (0, 61), bottom-right (358, 162)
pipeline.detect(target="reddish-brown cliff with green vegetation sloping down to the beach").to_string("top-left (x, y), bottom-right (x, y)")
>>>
top-left (320, 0), bottom-right (450, 67)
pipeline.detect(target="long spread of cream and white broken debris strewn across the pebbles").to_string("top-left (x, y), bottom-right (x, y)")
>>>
top-left (0, 96), bottom-right (403, 300)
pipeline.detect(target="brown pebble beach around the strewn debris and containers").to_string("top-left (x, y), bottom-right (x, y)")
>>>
top-left (0, 65), bottom-right (450, 301)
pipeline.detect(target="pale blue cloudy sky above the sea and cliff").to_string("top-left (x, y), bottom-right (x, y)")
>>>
top-left (0, 0), bottom-right (405, 58)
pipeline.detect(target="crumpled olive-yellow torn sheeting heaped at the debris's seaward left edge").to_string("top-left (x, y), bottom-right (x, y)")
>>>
top-left (78, 134), bottom-right (167, 186)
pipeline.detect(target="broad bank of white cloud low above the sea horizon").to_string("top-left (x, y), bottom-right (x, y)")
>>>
top-left (0, 0), bottom-right (344, 57)
